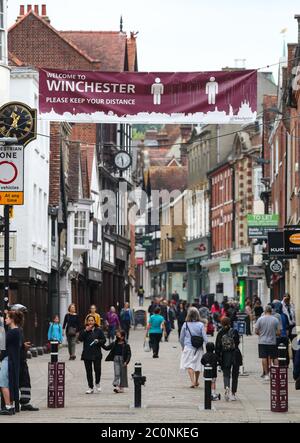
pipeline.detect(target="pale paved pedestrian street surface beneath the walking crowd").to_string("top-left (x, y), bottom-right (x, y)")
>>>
top-left (0, 320), bottom-right (300, 423)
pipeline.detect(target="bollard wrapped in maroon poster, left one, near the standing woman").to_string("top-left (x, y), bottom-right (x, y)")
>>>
top-left (48, 341), bottom-right (65, 409)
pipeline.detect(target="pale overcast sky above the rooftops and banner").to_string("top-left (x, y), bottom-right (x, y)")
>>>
top-left (8, 0), bottom-right (300, 76)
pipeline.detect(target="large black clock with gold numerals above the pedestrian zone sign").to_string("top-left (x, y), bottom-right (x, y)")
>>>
top-left (0, 103), bottom-right (36, 145)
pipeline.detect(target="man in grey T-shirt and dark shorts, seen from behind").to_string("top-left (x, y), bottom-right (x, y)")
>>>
top-left (255, 305), bottom-right (280, 380)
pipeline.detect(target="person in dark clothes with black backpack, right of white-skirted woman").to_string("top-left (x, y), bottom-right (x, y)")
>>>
top-left (216, 317), bottom-right (243, 401)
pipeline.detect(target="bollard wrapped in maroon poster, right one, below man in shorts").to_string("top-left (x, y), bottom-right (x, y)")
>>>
top-left (270, 343), bottom-right (289, 413)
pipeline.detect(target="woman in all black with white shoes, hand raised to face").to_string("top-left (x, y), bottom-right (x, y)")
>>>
top-left (79, 315), bottom-right (106, 394)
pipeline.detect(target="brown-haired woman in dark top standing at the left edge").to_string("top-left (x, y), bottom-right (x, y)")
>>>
top-left (0, 311), bottom-right (23, 415)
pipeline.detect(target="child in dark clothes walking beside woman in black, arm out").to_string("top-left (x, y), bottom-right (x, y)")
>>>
top-left (103, 331), bottom-right (131, 394)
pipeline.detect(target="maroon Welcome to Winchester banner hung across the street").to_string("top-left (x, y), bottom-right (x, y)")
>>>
top-left (39, 69), bottom-right (257, 124)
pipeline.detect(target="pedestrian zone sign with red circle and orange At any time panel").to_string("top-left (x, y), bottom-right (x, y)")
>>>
top-left (0, 145), bottom-right (24, 205)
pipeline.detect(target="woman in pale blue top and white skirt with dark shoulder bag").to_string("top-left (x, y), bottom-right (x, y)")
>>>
top-left (180, 307), bottom-right (207, 388)
